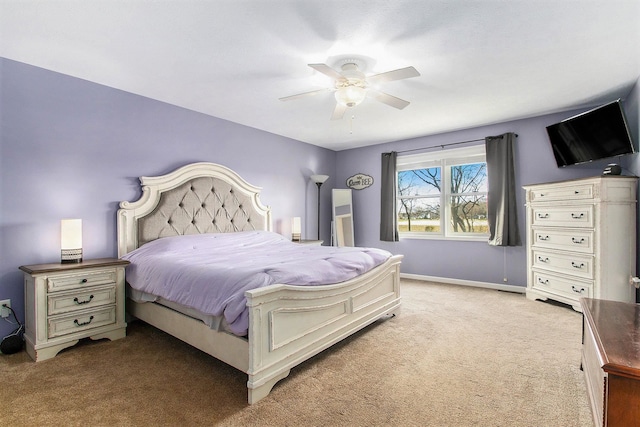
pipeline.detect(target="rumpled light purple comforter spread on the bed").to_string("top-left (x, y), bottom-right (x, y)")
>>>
top-left (122, 231), bottom-right (391, 335)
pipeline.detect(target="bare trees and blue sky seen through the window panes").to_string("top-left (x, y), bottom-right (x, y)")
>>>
top-left (398, 162), bottom-right (488, 233)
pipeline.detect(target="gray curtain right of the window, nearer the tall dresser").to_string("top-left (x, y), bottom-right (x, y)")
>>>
top-left (485, 132), bottom-right (522, 246)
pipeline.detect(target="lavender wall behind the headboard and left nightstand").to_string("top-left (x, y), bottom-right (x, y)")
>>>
top-left (0, 59), bottom-right (337, 338)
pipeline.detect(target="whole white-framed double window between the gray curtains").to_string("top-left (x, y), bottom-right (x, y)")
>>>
top-left (397, 145), bottom-right (489, 240)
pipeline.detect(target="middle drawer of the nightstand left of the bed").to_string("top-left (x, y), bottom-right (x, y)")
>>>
top-left (47, 284), bottom-right (116, 316)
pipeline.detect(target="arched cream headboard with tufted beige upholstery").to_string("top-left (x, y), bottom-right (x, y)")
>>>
top-left (118, 163), bottom-right (271, 256)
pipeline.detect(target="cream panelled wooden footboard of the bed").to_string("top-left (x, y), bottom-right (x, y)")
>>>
top-left (246, 255), bottom-right (402, 403)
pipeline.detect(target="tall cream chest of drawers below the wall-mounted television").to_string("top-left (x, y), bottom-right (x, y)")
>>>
top-left (524, 176), bottom-right (637, 311)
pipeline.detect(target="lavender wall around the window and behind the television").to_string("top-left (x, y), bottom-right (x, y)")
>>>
top-left (336, 85), bottom-right (640, 286)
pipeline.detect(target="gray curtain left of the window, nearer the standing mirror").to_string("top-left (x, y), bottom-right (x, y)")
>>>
top-left (380, 151), bottom-right (398, 242)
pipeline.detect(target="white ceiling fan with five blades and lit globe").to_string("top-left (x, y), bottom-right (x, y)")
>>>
top-left (280, 59), bottom-right (420, 120)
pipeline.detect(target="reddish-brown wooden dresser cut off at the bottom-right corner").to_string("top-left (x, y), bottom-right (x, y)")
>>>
top-left (580, 298), bottom-right (640, 427)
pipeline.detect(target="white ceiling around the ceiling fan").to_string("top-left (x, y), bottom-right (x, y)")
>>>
top-left (0, 0), bottom-right (640, 150)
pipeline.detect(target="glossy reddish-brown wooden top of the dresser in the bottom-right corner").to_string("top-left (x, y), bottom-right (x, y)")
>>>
top-left (580, 298), bottom-right (640, 379)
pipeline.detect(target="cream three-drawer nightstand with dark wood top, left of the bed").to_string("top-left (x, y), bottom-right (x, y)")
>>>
top-left (20, 258), bottom-right (129, 362)
